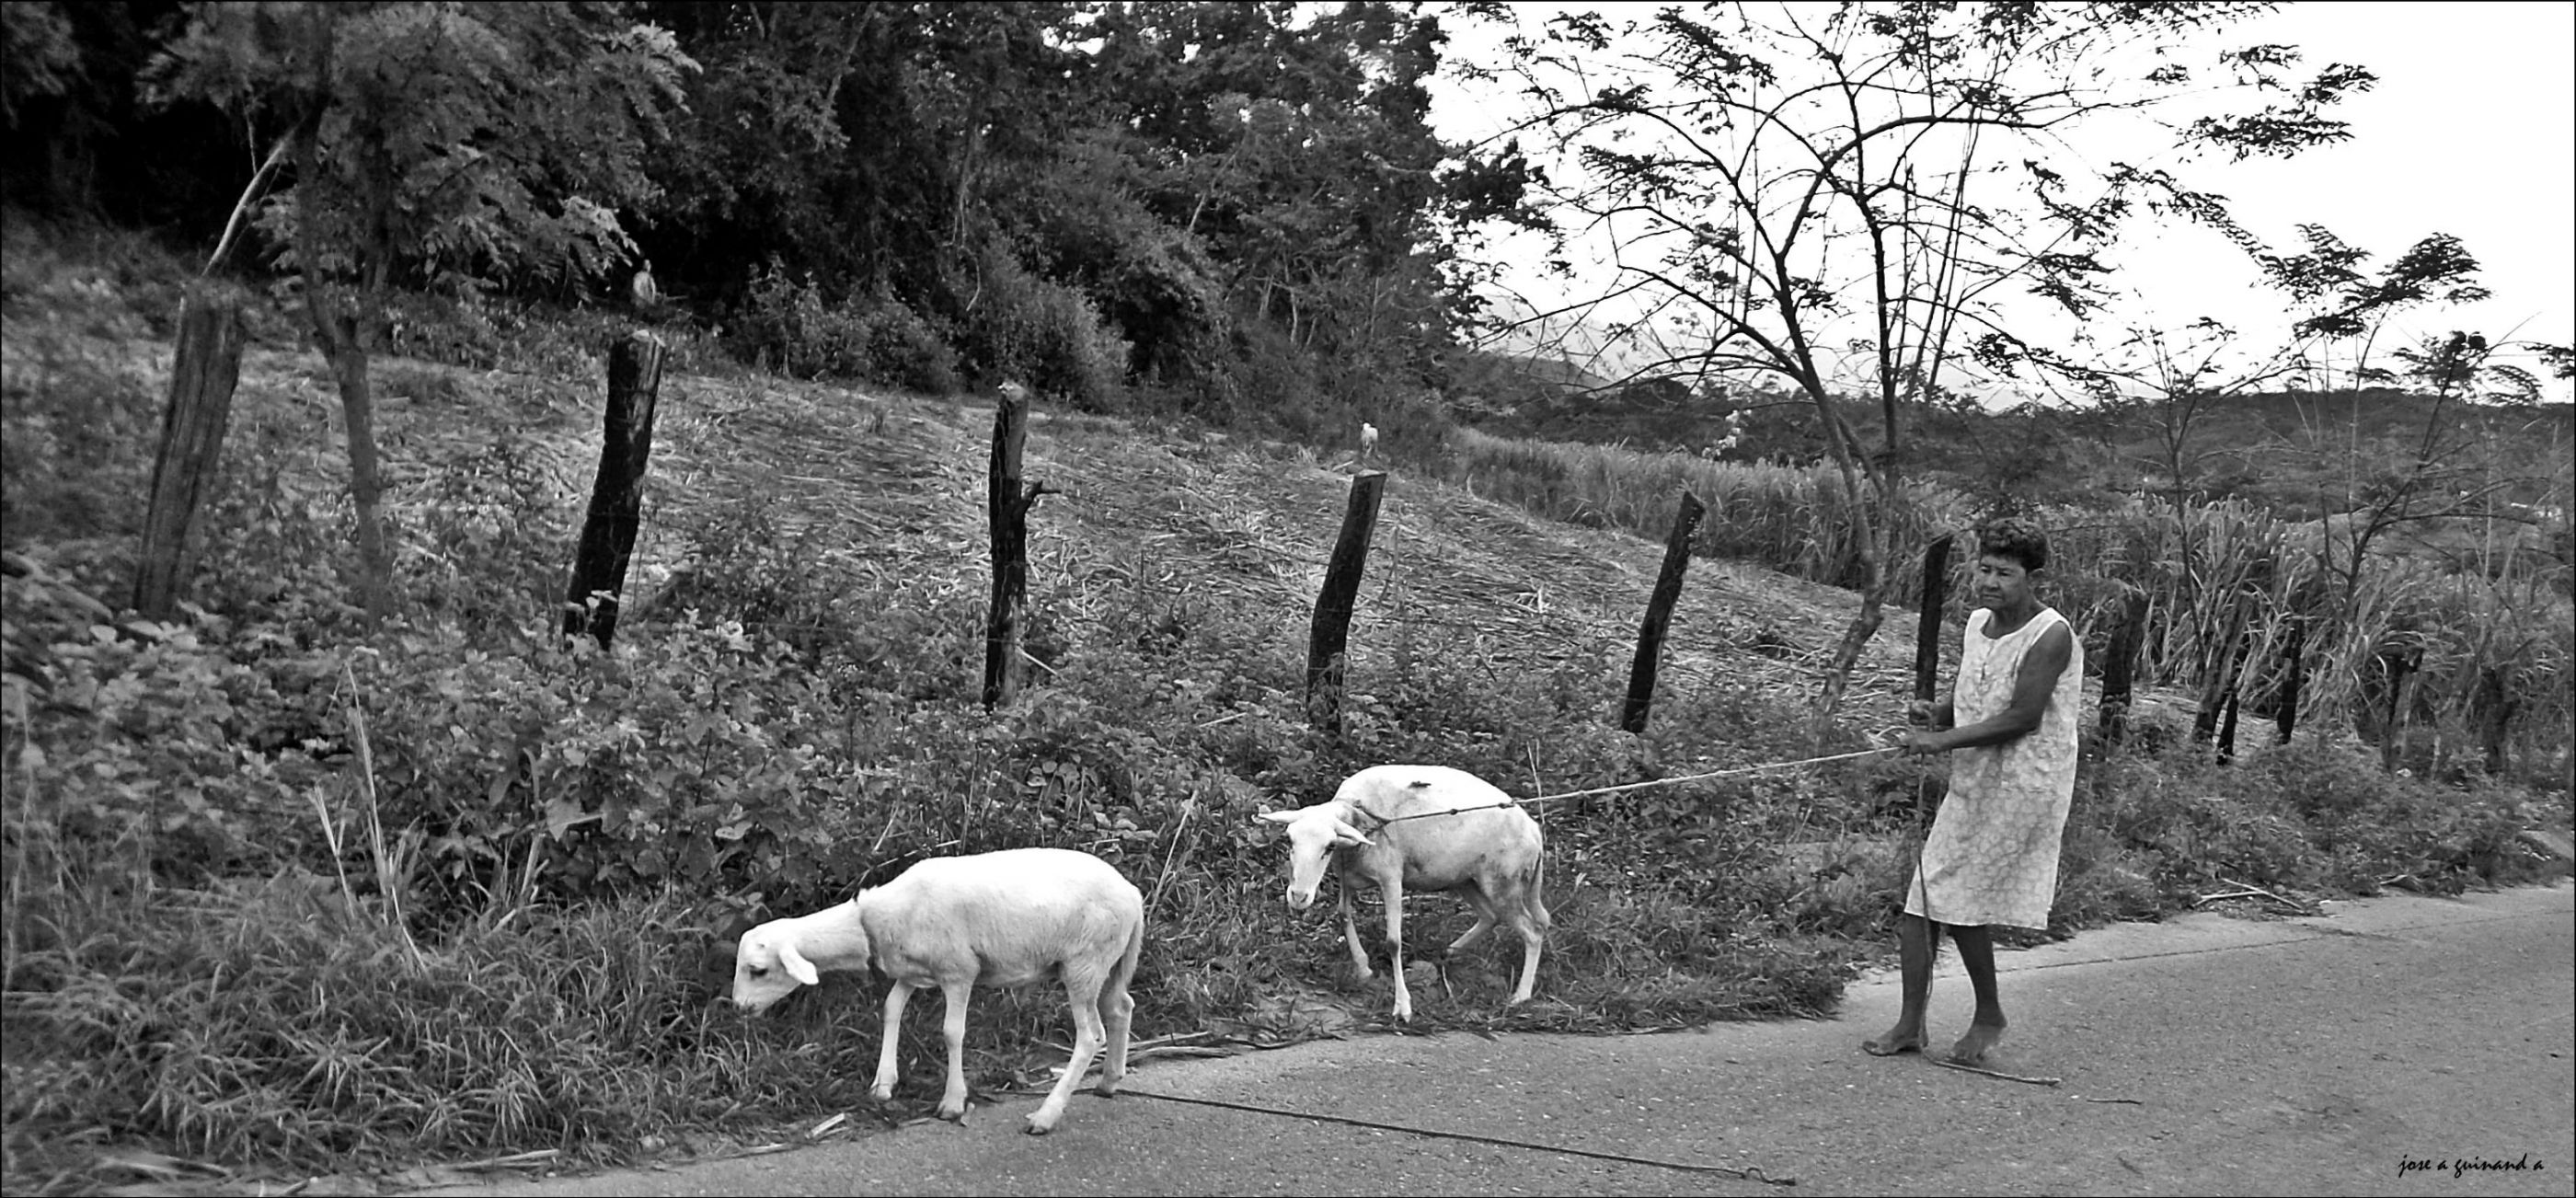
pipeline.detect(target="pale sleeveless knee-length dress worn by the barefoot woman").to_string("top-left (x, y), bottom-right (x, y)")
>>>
top-left (1906, 608), bottom-right (2084, 930)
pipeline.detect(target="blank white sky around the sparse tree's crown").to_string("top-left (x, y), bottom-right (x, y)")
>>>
top-left (1432, 0), bottom-right (2576, 402)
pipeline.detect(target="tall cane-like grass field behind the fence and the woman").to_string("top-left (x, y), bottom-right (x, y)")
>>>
top-left (1398, 431), bottom-right (2576, 780)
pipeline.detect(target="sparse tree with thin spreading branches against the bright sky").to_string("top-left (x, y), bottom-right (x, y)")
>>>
top-left (1510, 3), bottom-right (2373, 714)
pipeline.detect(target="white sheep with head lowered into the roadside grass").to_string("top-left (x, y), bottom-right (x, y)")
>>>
top-left (734, 847), bottom-right (1144, 1136)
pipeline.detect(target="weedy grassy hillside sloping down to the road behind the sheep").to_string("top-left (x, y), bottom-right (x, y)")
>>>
top-left (0, 219), bottom-right (2566, 1192)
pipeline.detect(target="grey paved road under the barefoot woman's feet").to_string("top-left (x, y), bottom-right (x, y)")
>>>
top-left (412, 881), bottom-right (2576, 1198)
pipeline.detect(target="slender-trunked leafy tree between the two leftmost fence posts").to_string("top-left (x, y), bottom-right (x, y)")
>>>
top-left (149, 3), bottom-right (696, 618)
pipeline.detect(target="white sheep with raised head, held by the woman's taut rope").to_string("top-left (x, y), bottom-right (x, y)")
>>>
top-left (1259, 766), bottom-right (1548, 1020)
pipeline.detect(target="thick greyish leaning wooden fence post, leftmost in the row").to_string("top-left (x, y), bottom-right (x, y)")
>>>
top-left (134, 286), bottom-right (242, 621)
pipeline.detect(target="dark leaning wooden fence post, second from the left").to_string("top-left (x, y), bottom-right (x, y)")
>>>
top-left (564, 329), bottom-right (667, 650)
